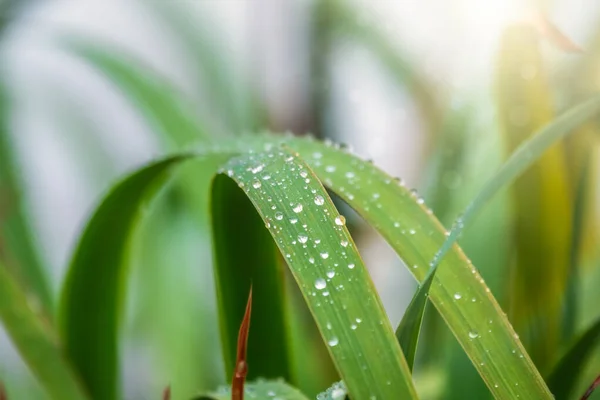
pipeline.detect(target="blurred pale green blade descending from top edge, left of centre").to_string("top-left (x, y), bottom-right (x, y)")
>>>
top-left (145, 2), bottom-right (263, 133)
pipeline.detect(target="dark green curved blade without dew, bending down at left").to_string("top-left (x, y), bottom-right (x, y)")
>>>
top-left (59, 156), bottom-right (196, 400)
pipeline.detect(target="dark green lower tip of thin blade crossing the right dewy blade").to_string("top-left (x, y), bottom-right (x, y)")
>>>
top-left (396, 264), bottom-right (435, 371)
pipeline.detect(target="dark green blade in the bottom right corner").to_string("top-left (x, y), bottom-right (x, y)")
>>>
top-left (546, 319), bottom-right (600, 400)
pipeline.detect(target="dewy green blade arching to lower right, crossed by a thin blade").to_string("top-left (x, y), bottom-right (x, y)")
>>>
top-left (282, 140), bottom-right (551, 399)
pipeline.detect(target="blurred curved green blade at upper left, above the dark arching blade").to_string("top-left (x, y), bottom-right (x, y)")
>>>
top-left (63, 40), bottom-right (209, 148)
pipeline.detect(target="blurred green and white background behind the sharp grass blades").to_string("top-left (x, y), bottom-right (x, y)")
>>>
top-left (0, 0), bottom-right (600, 400)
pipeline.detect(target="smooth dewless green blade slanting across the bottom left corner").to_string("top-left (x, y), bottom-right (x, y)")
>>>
top-left (0, 264), bottom-right (88, 400)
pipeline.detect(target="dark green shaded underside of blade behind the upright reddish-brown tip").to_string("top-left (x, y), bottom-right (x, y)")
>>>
top-left (211, 175), bottom-right (295, 383)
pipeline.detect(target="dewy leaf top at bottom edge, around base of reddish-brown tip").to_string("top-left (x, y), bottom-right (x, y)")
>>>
top-left (194, 380), bottom-right (308, 400)
